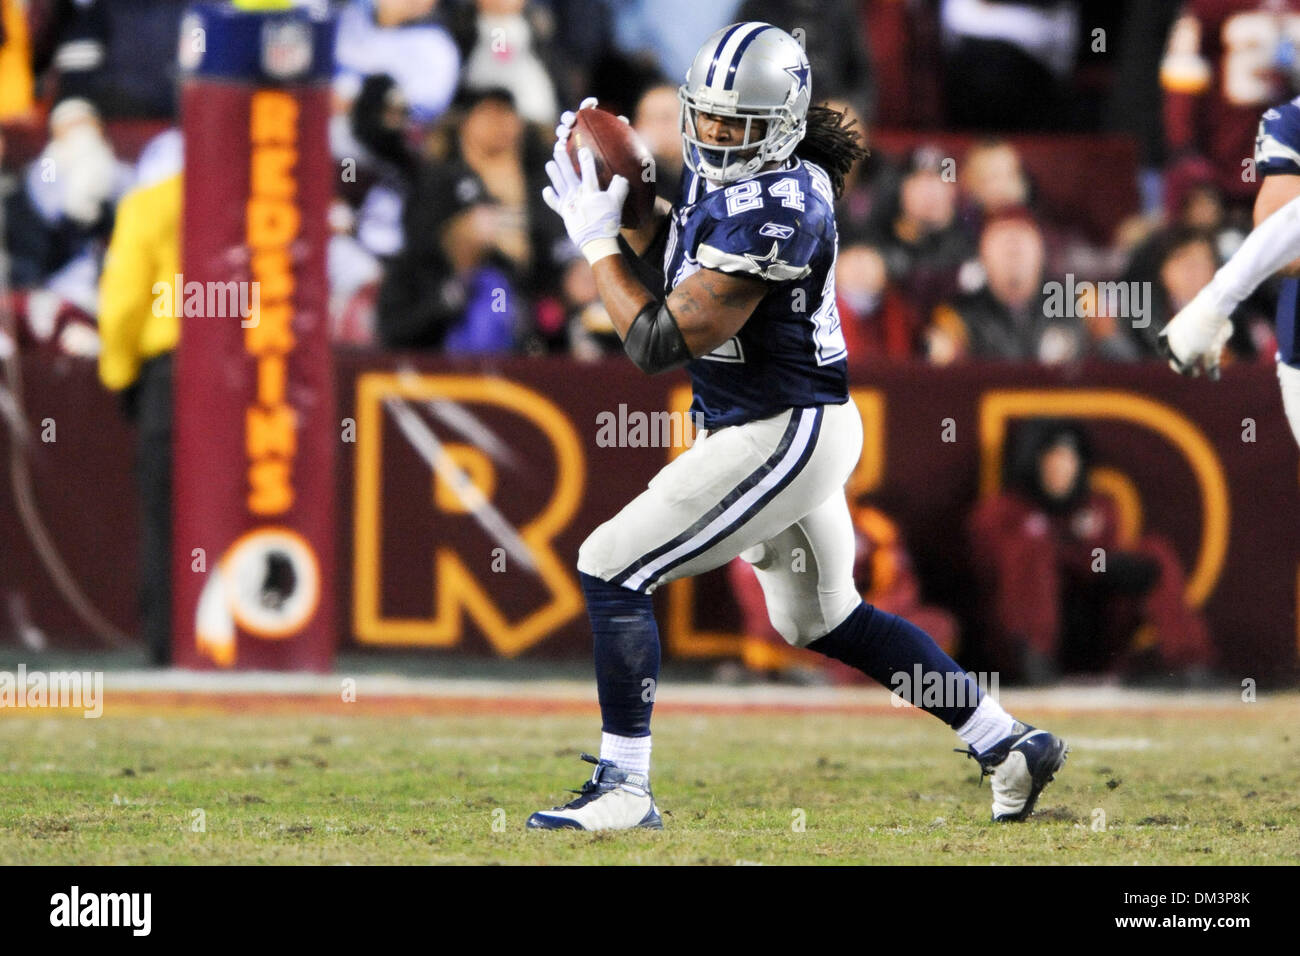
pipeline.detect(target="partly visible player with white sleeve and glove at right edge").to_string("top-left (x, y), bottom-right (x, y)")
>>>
top-left (1160, 91), bottom-right (1300, 444)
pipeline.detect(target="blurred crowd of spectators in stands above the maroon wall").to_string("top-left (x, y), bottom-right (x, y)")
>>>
top-left (0, 0), bottom-right (1284, 672)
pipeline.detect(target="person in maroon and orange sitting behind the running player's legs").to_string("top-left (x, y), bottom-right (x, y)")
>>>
top-left (718, 498), bottom-right (961, 684)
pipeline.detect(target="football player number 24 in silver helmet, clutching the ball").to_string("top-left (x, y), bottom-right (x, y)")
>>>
top-left (528, 22), bottom-right (1066, 830)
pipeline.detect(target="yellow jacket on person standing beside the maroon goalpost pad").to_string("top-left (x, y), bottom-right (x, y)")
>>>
top-left (99, 173), bottom-right (182, 392)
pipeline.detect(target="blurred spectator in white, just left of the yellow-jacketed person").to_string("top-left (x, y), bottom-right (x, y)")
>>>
top-left (4, 99), bottom-right (133, 306)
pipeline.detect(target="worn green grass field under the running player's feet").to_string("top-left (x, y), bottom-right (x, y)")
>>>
top-left (0, 695), bottom-right (1300, 865)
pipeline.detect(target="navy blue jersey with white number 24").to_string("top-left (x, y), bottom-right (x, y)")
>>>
top-left (663, 159), bottom-right (849, 428)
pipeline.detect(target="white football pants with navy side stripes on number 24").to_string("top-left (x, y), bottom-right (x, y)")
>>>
top-left (577, 402), bottom-right (862, 646)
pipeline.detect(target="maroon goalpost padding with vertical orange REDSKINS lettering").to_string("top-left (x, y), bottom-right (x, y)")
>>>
top-left (172, 79), bottom-right (339, 670)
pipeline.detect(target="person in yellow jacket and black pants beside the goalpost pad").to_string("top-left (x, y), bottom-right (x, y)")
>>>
top-left (99, 131), bottom-right (183, 665)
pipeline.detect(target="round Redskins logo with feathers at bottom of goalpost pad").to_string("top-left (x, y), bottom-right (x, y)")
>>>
top-left (195, 528), bottom-right (321, 667)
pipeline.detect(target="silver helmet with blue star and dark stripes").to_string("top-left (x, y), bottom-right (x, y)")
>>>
top-left (677, 22), bottom-right (813, 182)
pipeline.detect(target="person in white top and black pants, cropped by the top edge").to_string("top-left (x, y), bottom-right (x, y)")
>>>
top-left (940, 0), bottom-right (1079, 131)
